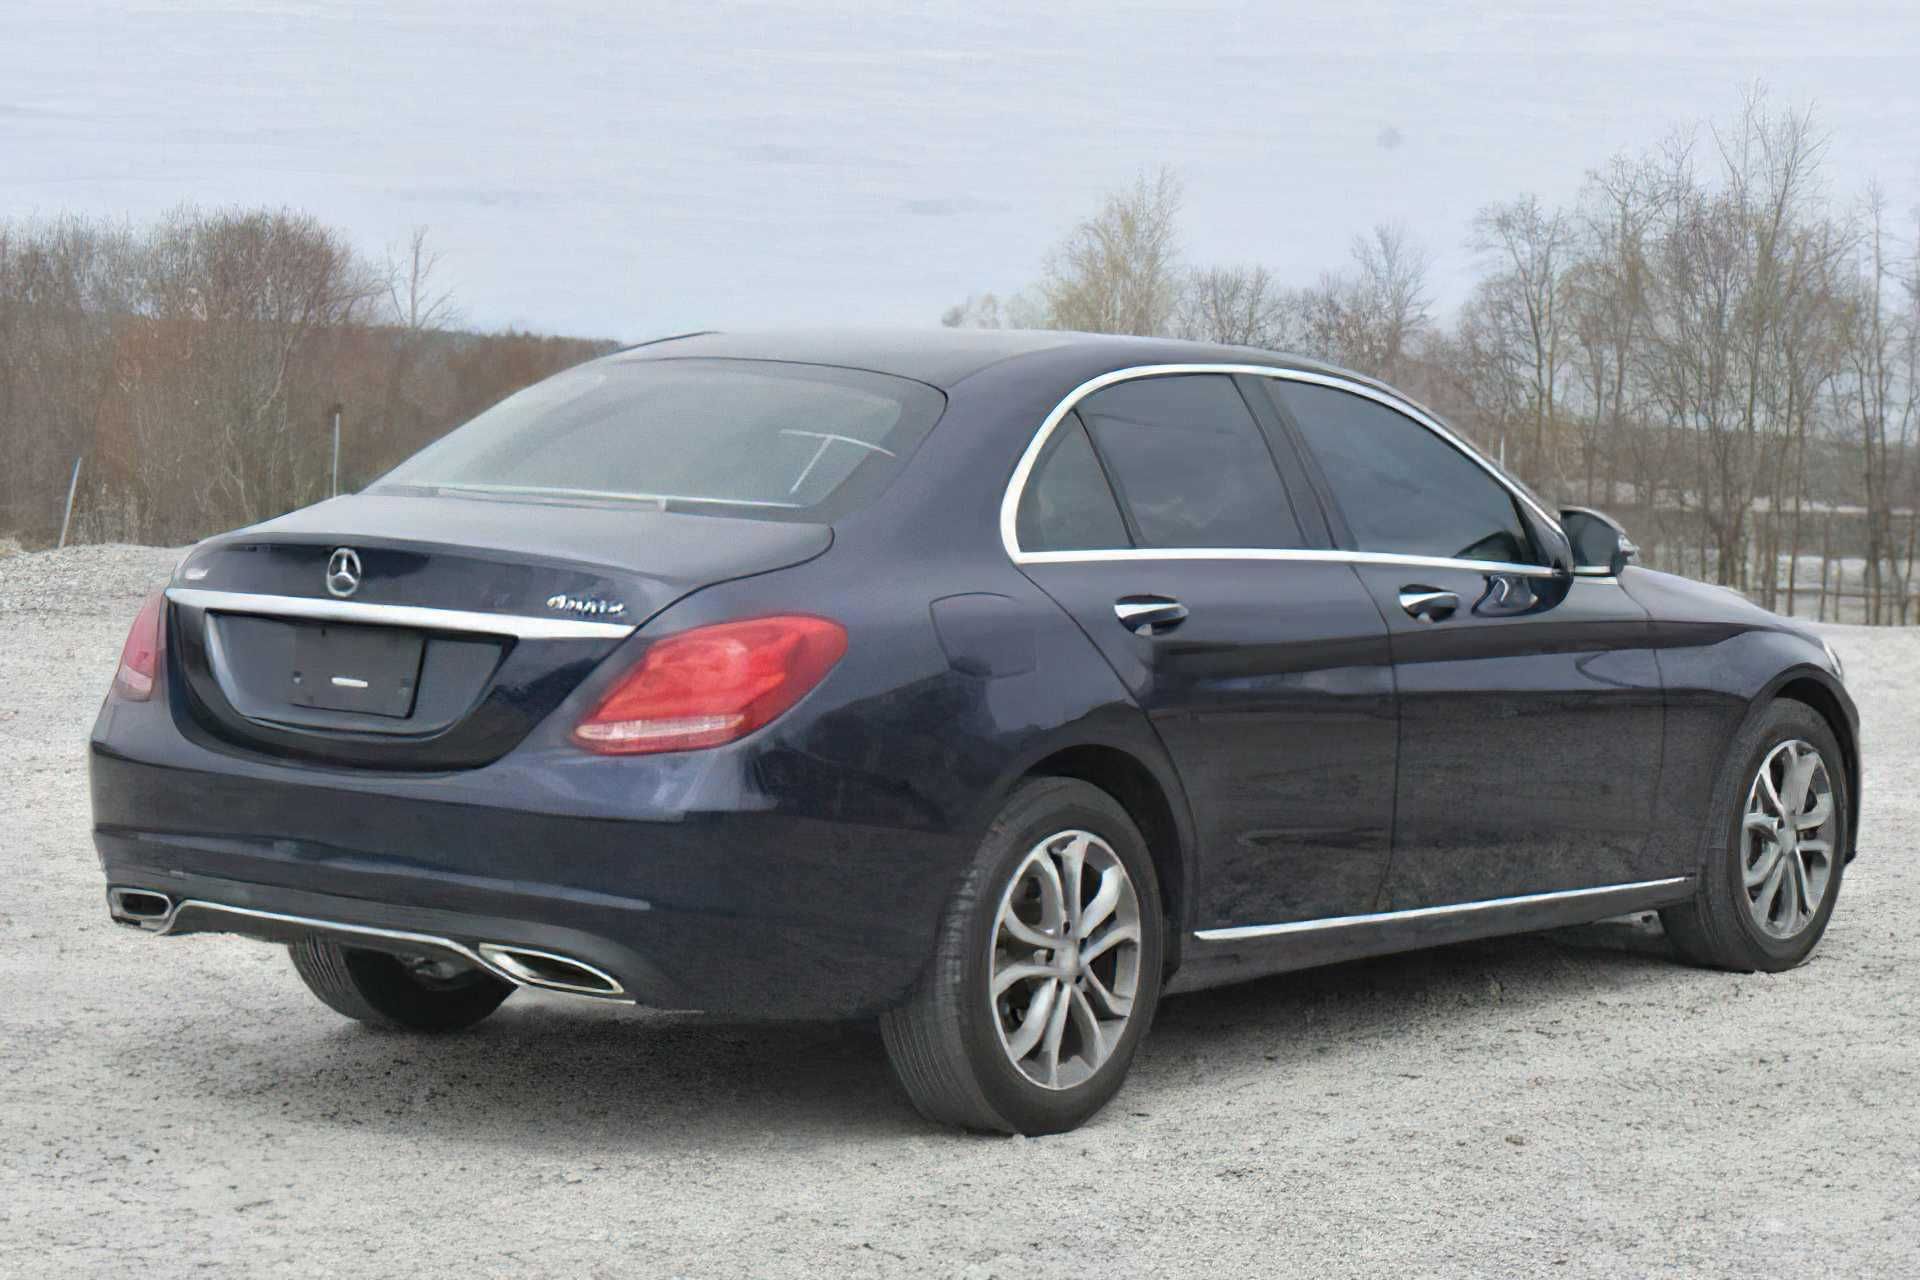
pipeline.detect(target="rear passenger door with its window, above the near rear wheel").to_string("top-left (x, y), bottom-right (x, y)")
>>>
top-left (1016, 374), bottom-right (1396, 929)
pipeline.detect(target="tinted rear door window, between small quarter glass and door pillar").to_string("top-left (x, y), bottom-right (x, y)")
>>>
top-left (1079, 374), bottom-right (1300, 547)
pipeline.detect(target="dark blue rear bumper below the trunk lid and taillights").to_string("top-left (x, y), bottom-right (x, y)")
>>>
top-left (90, 729), bottom-right (970, 1019)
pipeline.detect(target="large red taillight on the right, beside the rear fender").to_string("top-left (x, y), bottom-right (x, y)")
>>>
top-left (574, 614), bottom-right (847, 756)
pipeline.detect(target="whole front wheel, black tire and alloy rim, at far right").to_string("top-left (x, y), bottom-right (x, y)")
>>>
top-left (1661, 699), bottom-right (1853, 973)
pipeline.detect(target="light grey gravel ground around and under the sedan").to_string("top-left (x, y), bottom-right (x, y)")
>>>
top-left (0, 547), bottom-right (1920, 1280)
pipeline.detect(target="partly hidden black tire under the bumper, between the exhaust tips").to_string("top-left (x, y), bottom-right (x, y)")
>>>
top-left (286, 935), bottom-right (513, 1031)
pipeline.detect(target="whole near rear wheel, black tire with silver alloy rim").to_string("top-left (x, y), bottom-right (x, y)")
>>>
top-left (879, 777), bottom-right (1165, 1134)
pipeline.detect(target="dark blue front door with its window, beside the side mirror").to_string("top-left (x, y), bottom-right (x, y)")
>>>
top-left (1265, 378), bottom-right (1663, 910)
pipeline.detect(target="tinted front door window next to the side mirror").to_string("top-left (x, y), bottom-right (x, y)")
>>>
top-left (1267, 378), bottom-right (1538, 564)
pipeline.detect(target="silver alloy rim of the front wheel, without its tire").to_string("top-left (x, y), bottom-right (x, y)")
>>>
top-left (1740, 739), bottom-right (1836, 938)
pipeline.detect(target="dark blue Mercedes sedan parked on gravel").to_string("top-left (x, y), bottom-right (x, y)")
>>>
top-left (92, 332), bottom-right (1859, 1132)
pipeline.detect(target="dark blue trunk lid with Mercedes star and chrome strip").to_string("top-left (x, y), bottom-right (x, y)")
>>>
top-left (167, 493), bottom-right (831, 770)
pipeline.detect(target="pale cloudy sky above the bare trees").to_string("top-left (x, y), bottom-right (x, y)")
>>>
top-left (11, 0), bottom-right (1920, 342)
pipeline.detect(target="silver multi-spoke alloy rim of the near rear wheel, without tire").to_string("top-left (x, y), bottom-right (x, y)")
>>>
top-left (989, 831), bottom-right (1140, 1088)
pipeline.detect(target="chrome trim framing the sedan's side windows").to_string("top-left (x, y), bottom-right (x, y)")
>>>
top-left (1000, 363), bottom-right (1561, 578)
